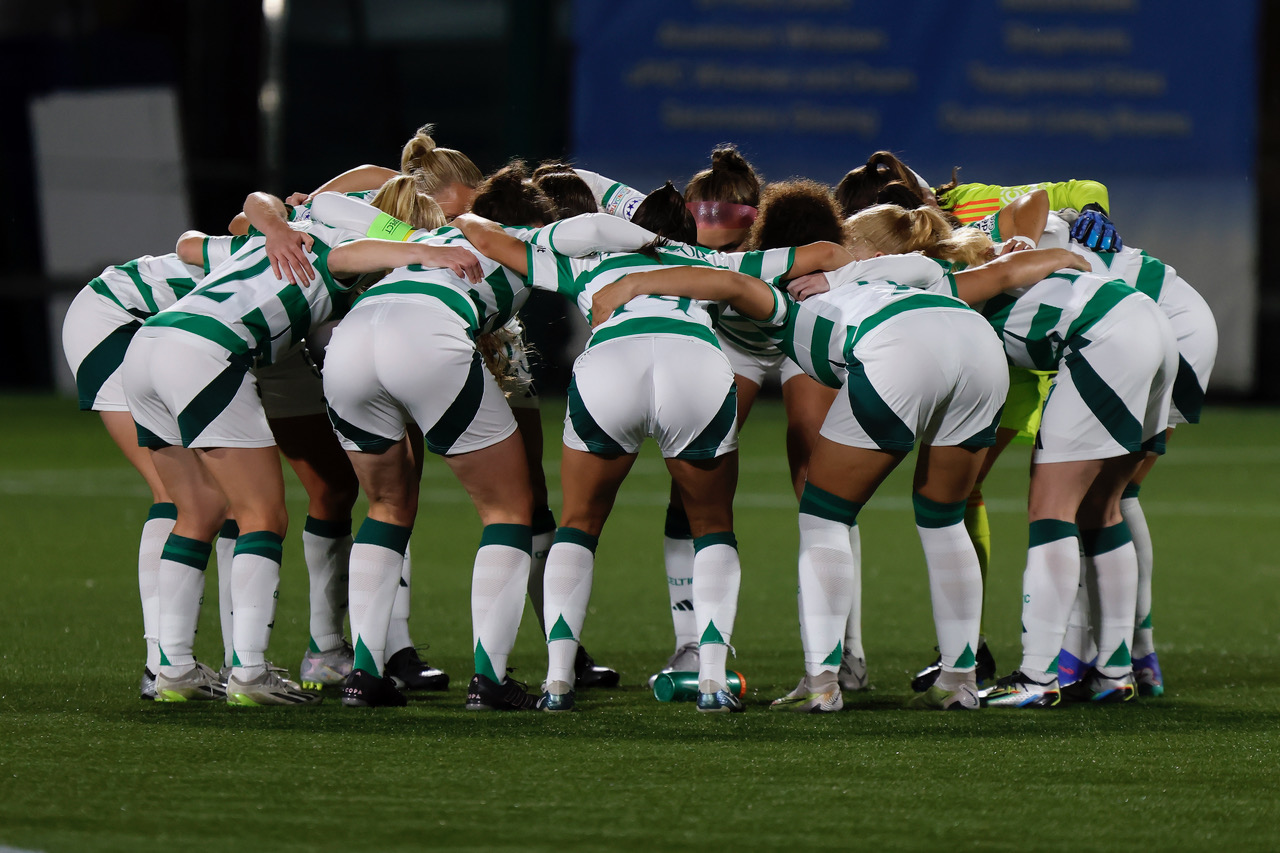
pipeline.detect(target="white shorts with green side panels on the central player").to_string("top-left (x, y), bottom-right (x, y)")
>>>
top-left (564, 334), bottom-right (737, 460)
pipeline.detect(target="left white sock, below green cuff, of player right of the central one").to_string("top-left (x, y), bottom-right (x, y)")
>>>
top-left (799, 512), bottom-right (854, 675)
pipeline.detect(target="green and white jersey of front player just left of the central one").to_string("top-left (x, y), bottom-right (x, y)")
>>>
top-left (356, 225), bottom-right (535, 337)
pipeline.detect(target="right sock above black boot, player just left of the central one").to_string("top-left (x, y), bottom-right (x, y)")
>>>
top-left (471, 524), bottom-right (532, 684)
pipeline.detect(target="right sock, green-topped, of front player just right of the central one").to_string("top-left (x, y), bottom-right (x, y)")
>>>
top-left (911, 493), bottom-right (982, 672)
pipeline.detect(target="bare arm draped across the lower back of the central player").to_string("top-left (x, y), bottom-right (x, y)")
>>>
top-left (591, 266), bottom-right (782, 325)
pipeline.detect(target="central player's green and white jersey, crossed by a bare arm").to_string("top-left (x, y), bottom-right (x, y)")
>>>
top-left (529, 243), bottom-right (795, 350)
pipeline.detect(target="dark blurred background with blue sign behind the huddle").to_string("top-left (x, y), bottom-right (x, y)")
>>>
top-left (0, 0), bottom-right (1280, 402)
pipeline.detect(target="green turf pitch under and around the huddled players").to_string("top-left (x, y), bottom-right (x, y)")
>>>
top-left (0, 397), bottom-right (1280, 850)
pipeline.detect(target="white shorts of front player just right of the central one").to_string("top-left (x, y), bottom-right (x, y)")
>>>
top-left (820, 309), bottom-right (1009, 452)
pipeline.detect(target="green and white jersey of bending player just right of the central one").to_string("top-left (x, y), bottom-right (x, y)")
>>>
top-left (760, 255), bottom-right (972, 388)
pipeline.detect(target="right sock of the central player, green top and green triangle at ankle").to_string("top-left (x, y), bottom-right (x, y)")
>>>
top-left (694, 533), bottom-right (742, 693)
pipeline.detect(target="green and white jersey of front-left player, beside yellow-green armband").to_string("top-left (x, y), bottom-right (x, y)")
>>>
top-left (146, 220), bottom-right (364, 366)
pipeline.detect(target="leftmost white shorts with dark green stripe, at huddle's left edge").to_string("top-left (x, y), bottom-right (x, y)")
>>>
top-left (63, 287), bottom-right (142, 411)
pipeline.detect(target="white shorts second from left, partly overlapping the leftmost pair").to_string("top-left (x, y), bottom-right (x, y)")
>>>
top-left (122, 327), bottom-right (275, 448)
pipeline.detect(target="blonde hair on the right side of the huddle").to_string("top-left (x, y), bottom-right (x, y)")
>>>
top-left (845, 205), bottom-right (993, 266)
